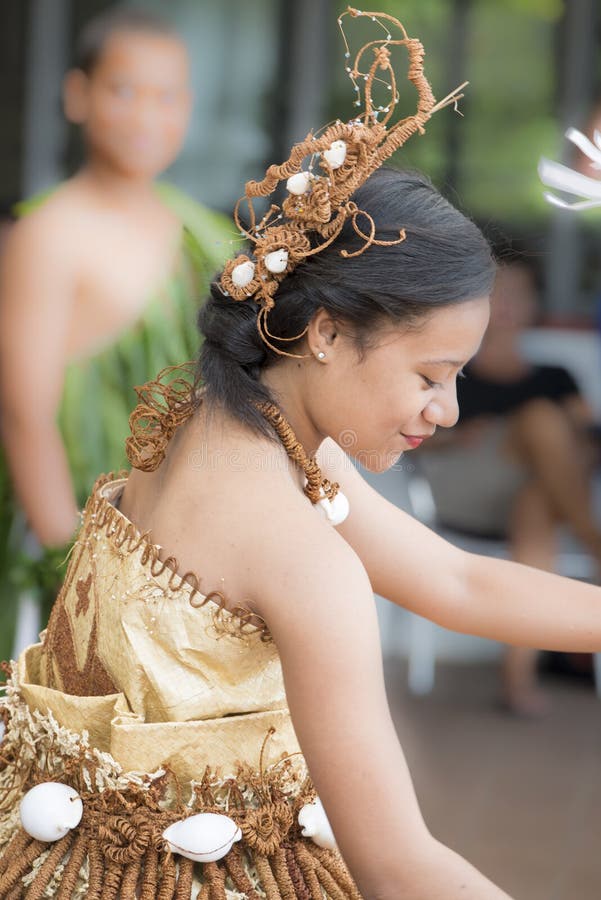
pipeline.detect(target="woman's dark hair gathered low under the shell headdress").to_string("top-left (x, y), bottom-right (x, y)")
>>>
top-left (198, 168), bottom-right (495, 434)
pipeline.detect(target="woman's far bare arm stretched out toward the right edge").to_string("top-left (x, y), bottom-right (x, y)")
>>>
top-left (327, 442), bottom-right (601, 652)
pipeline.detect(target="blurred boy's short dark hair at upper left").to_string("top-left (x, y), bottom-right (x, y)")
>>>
top-left (74, 7), bottom-right (179, 75)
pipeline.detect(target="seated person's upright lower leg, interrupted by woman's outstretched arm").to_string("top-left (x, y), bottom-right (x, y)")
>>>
top-left (502, 482), bottom-right (557, 716)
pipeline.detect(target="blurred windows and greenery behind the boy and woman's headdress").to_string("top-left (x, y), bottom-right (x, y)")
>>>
top-left (0, 0), bottom-right (601, 324)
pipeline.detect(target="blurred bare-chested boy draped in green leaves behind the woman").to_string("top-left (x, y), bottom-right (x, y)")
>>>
top-left (0, 10), bottom-right (231, 658)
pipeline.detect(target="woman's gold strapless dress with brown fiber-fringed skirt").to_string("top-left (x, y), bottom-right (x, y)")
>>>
top-left (0, 432), bottom-right (360, 900)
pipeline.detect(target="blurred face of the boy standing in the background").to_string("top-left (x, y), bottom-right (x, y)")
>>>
top-left (73, 32), bottom-right (191, 178)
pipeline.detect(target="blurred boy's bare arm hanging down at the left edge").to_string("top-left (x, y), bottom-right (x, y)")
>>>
top-left (0, 214), bottom-right (77, 546)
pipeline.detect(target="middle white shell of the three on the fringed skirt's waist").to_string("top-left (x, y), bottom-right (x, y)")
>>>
top-left (163, 813), bottom-right (242, 862)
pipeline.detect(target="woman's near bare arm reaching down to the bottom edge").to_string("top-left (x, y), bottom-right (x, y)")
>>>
top-left (244, 492), bottom-right (508, 900)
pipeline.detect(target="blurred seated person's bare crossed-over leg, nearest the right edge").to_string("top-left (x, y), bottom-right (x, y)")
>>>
top-left (508, 400), bottom-right (601, 565)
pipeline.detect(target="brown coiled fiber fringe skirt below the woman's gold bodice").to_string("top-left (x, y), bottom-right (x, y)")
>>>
top-left (0, 664), bottom-right (361, 900)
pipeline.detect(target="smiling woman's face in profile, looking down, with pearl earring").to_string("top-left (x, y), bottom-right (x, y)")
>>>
top-left (311, 297), bottom-right (490, 472)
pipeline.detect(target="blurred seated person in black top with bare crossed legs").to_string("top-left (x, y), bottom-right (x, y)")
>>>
top-left (419, 260), bottom-right (601, 716)
